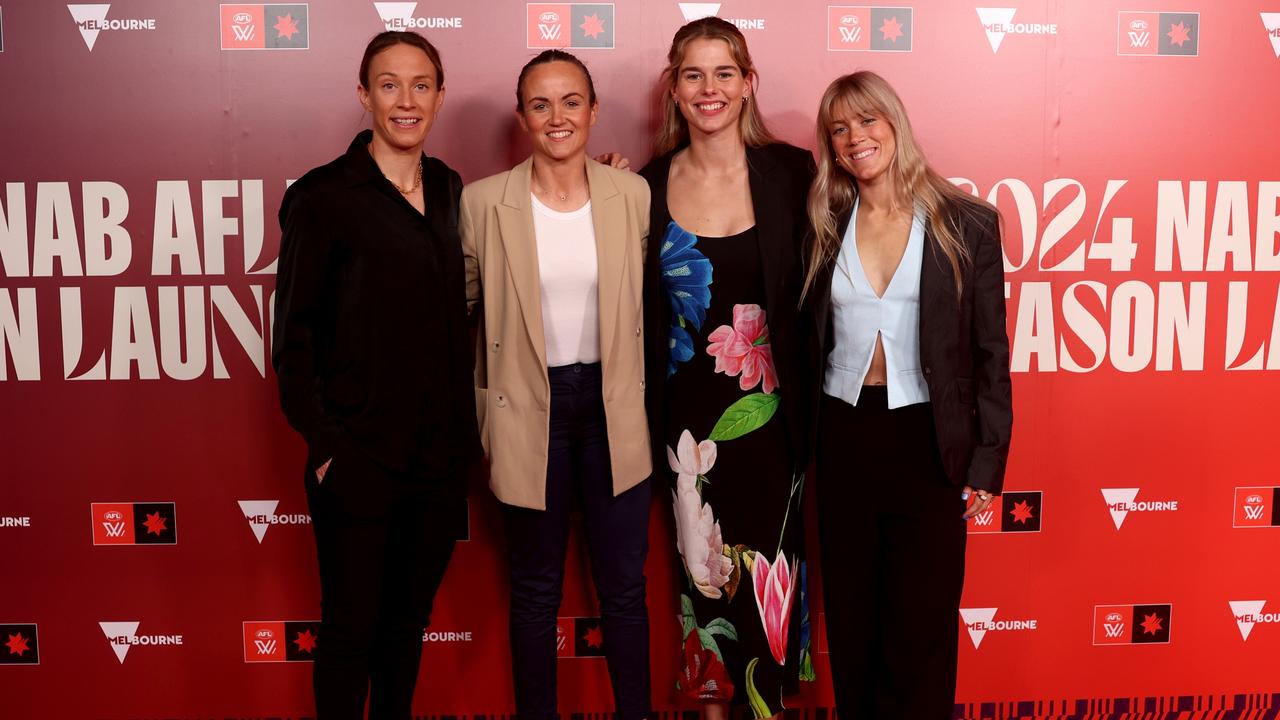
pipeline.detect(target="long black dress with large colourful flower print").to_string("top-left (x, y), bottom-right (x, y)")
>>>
top-left (659, 222), bottom-right (812, 717)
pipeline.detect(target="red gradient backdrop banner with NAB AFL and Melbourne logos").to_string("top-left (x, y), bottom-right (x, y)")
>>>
top-left (0, 0), bottom-right (1280, 719)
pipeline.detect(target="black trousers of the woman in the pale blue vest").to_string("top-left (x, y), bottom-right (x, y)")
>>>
top-left (817, 386), bottom-right (966, 720)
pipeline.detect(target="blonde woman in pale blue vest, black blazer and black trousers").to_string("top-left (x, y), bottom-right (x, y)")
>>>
top-left (804, 72), bottom-right (1012, 720)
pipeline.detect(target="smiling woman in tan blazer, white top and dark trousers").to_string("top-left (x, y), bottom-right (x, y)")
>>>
top-left (460, 50), bottom-right (652, 720)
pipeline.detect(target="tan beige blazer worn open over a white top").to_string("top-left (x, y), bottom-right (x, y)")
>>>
top-left (458, 158), bottom-right (653, 510)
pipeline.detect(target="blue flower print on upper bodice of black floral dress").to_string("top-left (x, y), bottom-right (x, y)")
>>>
top-left (658, 222), bottom-right (712, 377)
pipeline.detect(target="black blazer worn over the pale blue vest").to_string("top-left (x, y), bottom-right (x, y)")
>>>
top-left (805, 196), bottom-right (1014, 493)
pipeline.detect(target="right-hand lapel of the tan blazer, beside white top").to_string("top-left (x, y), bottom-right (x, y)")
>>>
top-left (586, 160), bottom-right (624, 368)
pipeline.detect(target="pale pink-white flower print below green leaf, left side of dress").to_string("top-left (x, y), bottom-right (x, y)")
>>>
top-left (667, 430), bottom-right (733, 600)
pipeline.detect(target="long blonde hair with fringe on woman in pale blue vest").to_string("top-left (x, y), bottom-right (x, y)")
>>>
top-left (800, 70), bottom-right (993, 300)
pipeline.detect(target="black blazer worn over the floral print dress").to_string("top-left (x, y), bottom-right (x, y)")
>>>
top-left (640, 142), bottom-right (814, 469)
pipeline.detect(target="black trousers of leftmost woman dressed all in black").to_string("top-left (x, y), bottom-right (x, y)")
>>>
top-left (306, 452), bottom-right (466, 720)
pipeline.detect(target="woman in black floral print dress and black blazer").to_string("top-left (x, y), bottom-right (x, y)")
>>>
top-left (640, 18), bottom-right (813, 720)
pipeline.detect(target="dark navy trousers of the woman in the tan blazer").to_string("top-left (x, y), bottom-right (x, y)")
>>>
top-left (503, 364), bottom-right (650, 720)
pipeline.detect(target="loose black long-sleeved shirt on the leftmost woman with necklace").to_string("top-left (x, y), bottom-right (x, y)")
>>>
top-left (271, 131), bottom-right (480, 492)
